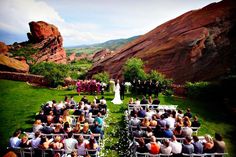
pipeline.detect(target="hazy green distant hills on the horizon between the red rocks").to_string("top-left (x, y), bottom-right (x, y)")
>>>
top-left (65, 35), bottom-right (140, 54)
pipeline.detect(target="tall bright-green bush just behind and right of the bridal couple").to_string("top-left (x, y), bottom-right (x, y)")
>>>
top-left (123, 58), bottom-right (146, 81)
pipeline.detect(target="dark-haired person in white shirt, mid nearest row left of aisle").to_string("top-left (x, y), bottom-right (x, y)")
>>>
top-left (63, 132), bottom-right (78, 154)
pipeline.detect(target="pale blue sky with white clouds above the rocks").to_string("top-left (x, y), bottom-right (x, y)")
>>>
top-left (0, 0), bottom-right (219, 46)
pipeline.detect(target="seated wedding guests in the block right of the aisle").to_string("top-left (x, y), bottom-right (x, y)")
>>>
top-left (128, 98), bottom-right (225, 156)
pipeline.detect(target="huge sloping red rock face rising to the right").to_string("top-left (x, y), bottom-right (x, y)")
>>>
top-left (89, 0), bottom-right (236, 83)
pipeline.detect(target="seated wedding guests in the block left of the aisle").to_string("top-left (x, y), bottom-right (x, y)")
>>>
top-left (10, 96), bottom-right (107, 156)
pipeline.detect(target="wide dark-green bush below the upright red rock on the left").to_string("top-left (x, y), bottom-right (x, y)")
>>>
top-left (30, 62), bottom-right (69, 87)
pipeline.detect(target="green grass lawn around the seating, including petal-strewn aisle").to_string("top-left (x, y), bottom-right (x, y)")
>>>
top-left (0, 80), bottom-right (235, 156)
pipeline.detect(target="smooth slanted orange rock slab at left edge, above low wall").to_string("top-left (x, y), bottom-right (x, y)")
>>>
top-left (0, 54), bottom-right (29, 72)
